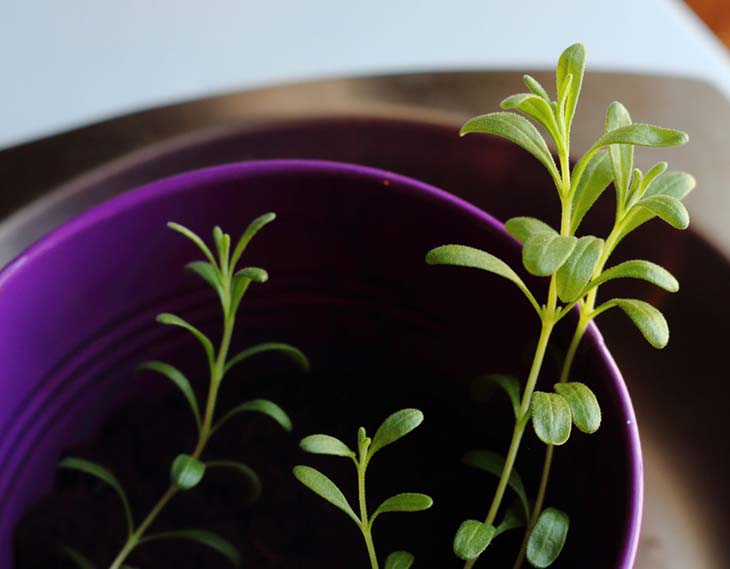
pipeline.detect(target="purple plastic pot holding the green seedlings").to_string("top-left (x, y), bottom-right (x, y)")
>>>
top-left (0, 161), bottom-right (642, 569)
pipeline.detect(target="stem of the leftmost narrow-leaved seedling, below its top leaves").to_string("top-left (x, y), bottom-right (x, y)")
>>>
top-left (109, 304), bottom-right (236, 569)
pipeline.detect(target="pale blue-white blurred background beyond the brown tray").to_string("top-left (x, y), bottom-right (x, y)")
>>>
top-left (0, 0), bottom-right (730, 147)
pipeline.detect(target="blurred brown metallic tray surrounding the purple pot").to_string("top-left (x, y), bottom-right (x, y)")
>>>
top-left (0, 72), bottom-right (730, 569)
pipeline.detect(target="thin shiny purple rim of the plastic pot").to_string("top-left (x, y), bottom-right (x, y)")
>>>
top-left (0, 159), bottom-right (644, 569)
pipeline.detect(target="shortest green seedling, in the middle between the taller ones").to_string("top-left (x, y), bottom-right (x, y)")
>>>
top-left (294, 409), bottom-right (433, 569)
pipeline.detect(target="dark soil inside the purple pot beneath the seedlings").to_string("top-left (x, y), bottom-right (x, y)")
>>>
top-left (15, 328), bottom-right (621, 569)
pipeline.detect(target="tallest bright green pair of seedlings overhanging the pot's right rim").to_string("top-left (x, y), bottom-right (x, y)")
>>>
top-left (426, 44), bottom-right (695, 569)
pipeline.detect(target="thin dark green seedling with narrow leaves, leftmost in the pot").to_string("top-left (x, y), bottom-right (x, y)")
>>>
top-left (59, 213), bottom-right (309, 569)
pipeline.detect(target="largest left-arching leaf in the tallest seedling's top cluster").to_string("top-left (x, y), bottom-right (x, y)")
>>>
top-left (459, 113), bottom-right (559, 181)
